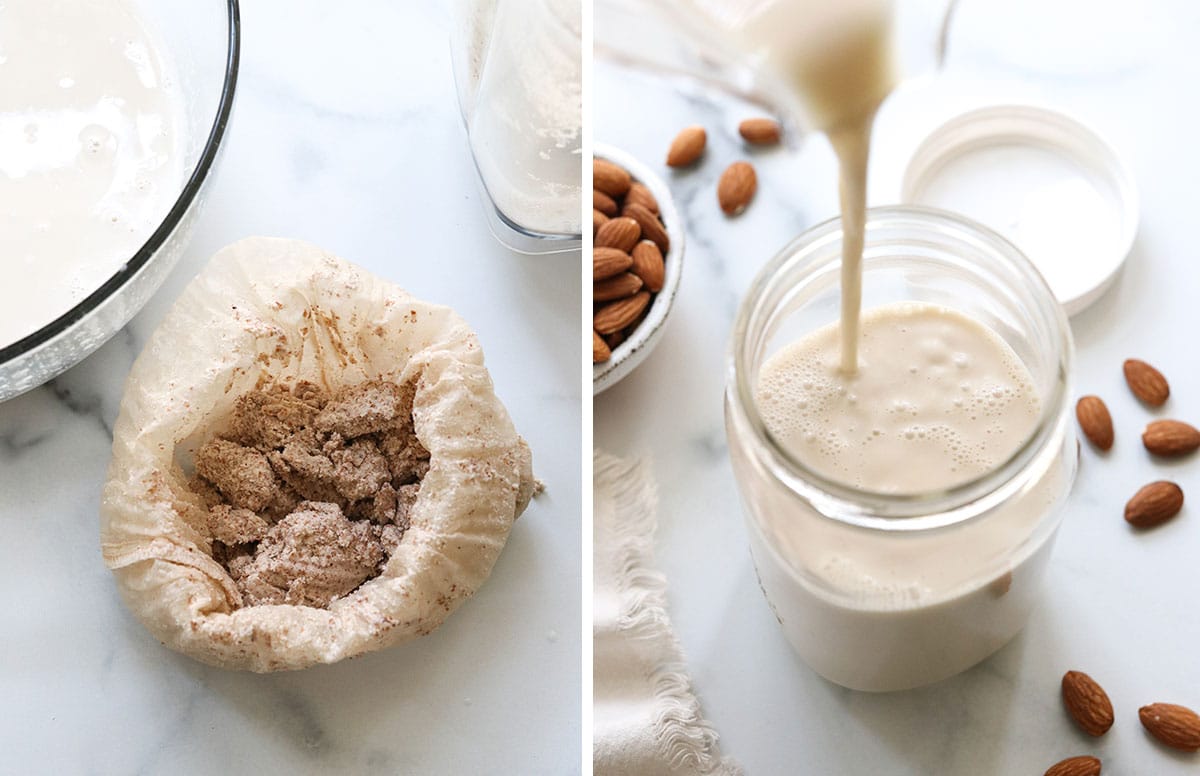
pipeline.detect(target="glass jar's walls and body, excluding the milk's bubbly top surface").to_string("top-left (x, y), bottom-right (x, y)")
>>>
top-left (725, 207), bottom-right (1079, 691)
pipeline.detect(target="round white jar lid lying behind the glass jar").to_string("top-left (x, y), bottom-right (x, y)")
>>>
top-left (900, 104), bottom-right (1138, 315)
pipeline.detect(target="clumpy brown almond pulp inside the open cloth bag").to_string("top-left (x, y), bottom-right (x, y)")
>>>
top-left (191, 380), bottom-right (430, 608)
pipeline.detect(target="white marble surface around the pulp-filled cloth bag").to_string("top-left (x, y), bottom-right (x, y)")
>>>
top-left (0, 0), bottom-right (581, 775)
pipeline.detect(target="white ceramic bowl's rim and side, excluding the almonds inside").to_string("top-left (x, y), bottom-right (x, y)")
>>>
top-left (592, 143), bottom-right (684, 396)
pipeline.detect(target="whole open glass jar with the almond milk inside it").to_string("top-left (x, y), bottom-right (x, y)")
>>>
top-left (726, 207), bottom-right (1078, 691)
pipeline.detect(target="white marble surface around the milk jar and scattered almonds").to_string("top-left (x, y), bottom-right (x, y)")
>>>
top-left (595, 0), bottom-right (1200, 775)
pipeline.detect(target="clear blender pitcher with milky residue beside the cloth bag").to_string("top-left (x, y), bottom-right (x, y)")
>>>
top-left (451, 0), bottom-right (583, 253)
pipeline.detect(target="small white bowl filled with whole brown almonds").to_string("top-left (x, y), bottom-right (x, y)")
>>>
top-left (592, 143), bottom-right (684, 396)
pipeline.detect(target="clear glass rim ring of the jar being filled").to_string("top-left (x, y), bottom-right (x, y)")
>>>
top-left (726, 205), bottom-right (1073, 531)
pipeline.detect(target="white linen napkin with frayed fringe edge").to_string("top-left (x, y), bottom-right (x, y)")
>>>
top-left (592, 451), bottom-right (742, 776)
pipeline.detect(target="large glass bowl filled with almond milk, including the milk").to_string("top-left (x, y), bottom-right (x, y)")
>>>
top-left (0, 0), bottom-right (239, 401)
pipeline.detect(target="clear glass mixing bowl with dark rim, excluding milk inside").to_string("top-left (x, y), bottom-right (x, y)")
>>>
top-left (0, 0), bottom-right (241, 401)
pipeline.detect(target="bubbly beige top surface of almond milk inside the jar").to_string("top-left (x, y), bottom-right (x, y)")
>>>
top-left (757, 302), bottom-right (1039, 493)
